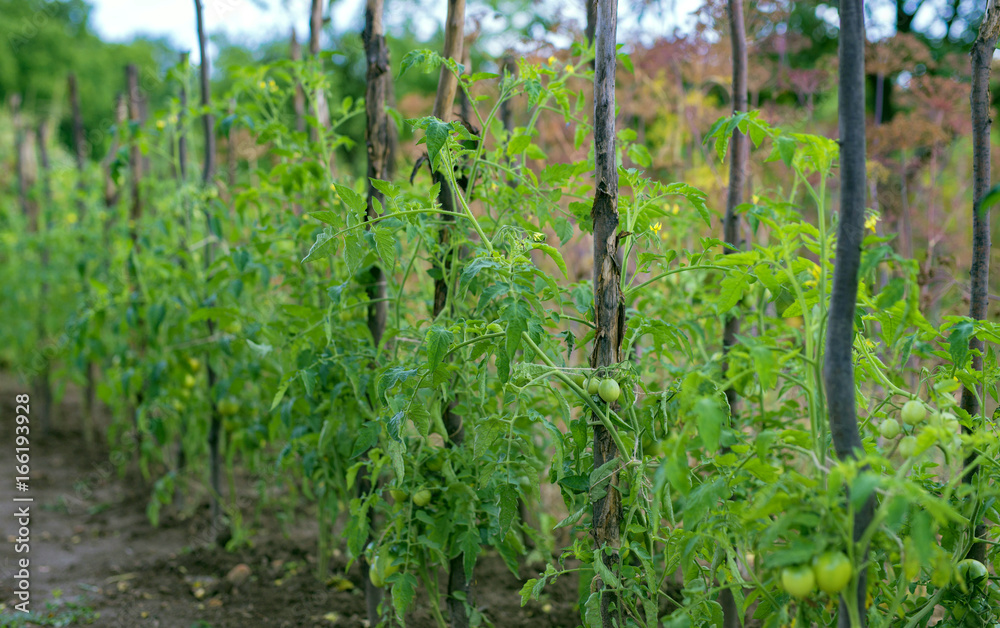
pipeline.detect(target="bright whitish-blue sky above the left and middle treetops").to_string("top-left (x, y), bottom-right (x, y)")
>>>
top-left (90, 0), bottom-right (701, 63)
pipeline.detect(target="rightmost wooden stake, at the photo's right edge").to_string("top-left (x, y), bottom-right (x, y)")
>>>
top-left (961, 0), bottom-right (1000, 562)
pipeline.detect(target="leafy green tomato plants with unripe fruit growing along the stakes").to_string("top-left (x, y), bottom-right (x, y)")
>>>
top-left (0, 2), bottom-right (1000, 627)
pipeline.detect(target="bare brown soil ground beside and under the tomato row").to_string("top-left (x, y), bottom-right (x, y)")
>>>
top-left (0, 379), bottom-right (579, 628)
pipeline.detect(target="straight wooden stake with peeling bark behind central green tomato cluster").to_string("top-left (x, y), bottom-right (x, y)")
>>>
top-left (590, 0), bottom-right (625, 628)
